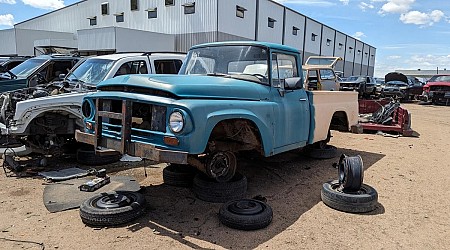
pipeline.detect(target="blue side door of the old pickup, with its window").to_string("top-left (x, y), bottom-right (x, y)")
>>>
top-left (271, 52), bottom-right (310, 150)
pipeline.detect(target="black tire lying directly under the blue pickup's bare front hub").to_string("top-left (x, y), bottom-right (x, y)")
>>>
top-left (192, 173), bottom-right (247, 203)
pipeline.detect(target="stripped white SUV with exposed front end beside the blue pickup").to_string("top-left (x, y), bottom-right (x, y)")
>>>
top-left (0, 53), bottom-right (186, 155)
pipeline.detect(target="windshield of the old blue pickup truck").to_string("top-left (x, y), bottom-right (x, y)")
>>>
top-left (180, 45), bottom-right (269, 84)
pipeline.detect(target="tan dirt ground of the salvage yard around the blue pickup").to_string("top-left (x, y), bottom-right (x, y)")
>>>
top-left (0, 104), bottom-right (450, 249)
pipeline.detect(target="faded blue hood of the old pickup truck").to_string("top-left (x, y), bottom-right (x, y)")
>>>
top-left (97, 75), bottom-right (269, 100)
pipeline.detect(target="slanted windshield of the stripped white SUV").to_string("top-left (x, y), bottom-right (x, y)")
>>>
top-left (66, 58), bottom-right (114, 85)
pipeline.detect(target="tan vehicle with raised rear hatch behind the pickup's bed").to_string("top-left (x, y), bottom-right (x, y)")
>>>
top-left (303, 56), bottom-right (342, 91)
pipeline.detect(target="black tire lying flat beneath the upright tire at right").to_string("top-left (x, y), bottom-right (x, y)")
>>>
top-left (321, 180), bottom-right (378, 213)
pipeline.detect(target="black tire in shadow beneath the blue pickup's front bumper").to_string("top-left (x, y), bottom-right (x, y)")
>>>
top-left (163, 164), bottom-right (198, 187)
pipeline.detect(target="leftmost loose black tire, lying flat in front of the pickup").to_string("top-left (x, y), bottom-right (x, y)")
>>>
top-left (80, 191), bottom-right (145, 227)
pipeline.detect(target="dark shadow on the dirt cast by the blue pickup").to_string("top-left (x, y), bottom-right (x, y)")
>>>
top-left (124, 149), bottom-right (384, 249)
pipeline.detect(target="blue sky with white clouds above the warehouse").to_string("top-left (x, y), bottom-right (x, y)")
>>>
top-left (0, 0), bottom-right (450, 76)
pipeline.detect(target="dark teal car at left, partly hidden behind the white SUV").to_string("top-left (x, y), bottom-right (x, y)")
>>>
top-left (0, 55), bottom-right (81, 93)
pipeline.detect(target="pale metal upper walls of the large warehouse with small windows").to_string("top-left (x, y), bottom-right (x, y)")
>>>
top-left (11, 0), bottom-right (376, 76)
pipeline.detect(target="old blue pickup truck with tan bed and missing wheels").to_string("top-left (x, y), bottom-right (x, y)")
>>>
top-left (75, 41), bottom-right (358, 181)
